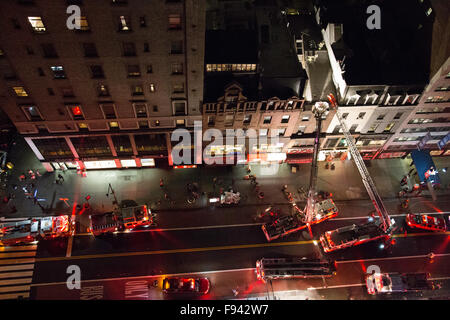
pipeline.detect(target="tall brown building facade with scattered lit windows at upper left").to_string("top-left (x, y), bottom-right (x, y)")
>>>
top-left (0, 0), bottom-right (205, 171)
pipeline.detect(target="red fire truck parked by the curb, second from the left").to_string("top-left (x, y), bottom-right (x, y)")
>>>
top-left (88, 204), bottom-right (156, 236)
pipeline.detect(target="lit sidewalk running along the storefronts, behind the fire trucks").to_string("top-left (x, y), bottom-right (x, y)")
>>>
top-left (0, 138), bottom-right (450, 218)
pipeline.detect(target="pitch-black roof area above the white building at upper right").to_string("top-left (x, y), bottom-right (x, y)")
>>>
top-left (317, 0), bottom-right (433, 85)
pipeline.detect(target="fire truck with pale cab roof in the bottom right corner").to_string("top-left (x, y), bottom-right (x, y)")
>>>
top-left (366, 272), bottom-right (436, 295)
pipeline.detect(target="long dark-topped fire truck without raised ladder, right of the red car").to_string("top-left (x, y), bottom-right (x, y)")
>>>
top-left (256, 257), bottom-right (336, 282)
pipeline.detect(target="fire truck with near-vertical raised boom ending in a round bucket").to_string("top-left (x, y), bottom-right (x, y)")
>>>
top-left (262, 102), bottom-right (338, 241)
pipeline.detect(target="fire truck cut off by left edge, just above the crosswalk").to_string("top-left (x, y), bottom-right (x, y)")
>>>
top-left (0, 215), bottom-right (71, 246)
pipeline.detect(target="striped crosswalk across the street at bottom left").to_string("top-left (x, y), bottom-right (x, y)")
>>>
top-left (0, 245), bottom-right (37, 300)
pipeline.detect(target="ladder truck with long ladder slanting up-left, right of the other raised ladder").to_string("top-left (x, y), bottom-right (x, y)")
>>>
top-left (320, 94), bottom-right (395, 252)
